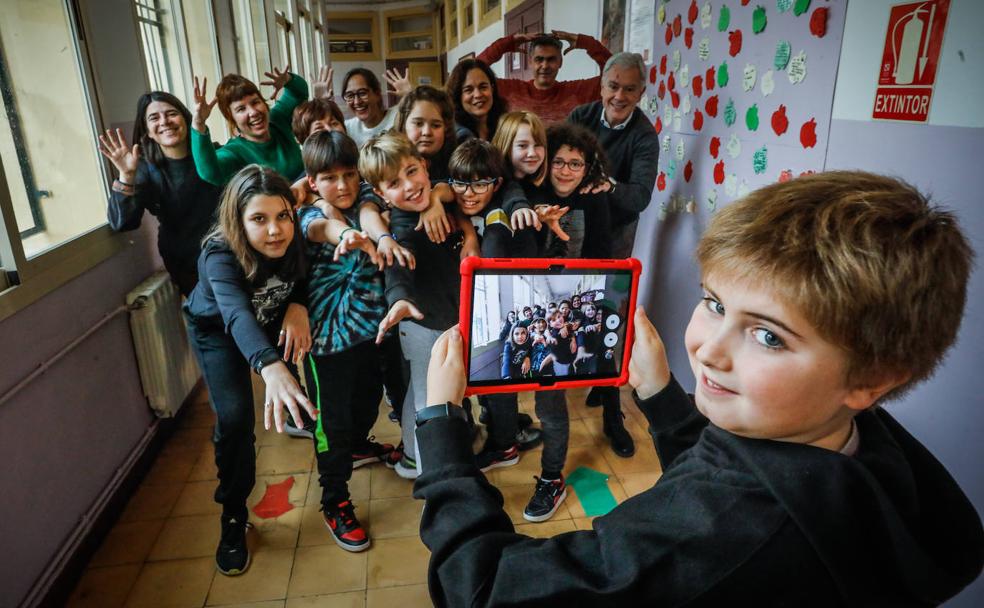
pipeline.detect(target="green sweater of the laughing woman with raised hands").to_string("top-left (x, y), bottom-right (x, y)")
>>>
top-left (191, 74), bottom-right (308, 186)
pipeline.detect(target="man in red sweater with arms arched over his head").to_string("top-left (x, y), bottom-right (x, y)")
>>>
top-left (478, 30), bottom-right (612, 123)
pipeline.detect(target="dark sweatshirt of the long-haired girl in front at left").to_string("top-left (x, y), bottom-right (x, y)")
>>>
top-left (184, 235), bottom-right (307, 369)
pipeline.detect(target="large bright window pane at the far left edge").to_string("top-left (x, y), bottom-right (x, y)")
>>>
top-left (0, 0), bottom-right (107, 257)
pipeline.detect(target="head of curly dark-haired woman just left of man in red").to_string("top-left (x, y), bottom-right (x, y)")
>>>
top-left (445, 59), bottom-right (509, 141)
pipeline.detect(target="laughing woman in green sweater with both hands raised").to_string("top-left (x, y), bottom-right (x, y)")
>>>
top-left (191, 68), bottom-right (308, 186)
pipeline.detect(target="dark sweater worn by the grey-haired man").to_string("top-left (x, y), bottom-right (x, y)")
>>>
top-left (567, 101), bottom-right (659, 228)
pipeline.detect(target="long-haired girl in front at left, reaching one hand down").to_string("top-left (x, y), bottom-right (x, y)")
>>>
top-left (184, 165), bottom-right (317, 576)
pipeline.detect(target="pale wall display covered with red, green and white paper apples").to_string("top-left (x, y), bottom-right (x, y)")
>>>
top-left (643, 0), bottom-right (847, 219)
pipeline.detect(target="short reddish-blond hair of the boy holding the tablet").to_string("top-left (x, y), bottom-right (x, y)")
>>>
top-left (697, 171), bottom-right (973, 400)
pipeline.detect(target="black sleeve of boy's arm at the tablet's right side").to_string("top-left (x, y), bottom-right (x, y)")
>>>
top-left (632, 376), bottom-right (708, 470)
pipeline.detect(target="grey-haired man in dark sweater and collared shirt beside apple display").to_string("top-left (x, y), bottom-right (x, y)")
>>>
top-left (567, 53), bottom-right (659, 458)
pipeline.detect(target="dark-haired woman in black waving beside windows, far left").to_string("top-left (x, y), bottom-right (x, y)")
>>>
top-left (99, 91), bottom-right (220, 296)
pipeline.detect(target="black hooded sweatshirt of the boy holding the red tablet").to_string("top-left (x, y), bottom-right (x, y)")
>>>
top-left (414, 380), bottom-right (984, 607)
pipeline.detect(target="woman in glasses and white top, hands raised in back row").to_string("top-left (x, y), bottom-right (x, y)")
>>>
top-left (342, 68), bottom-right (410, 148)
